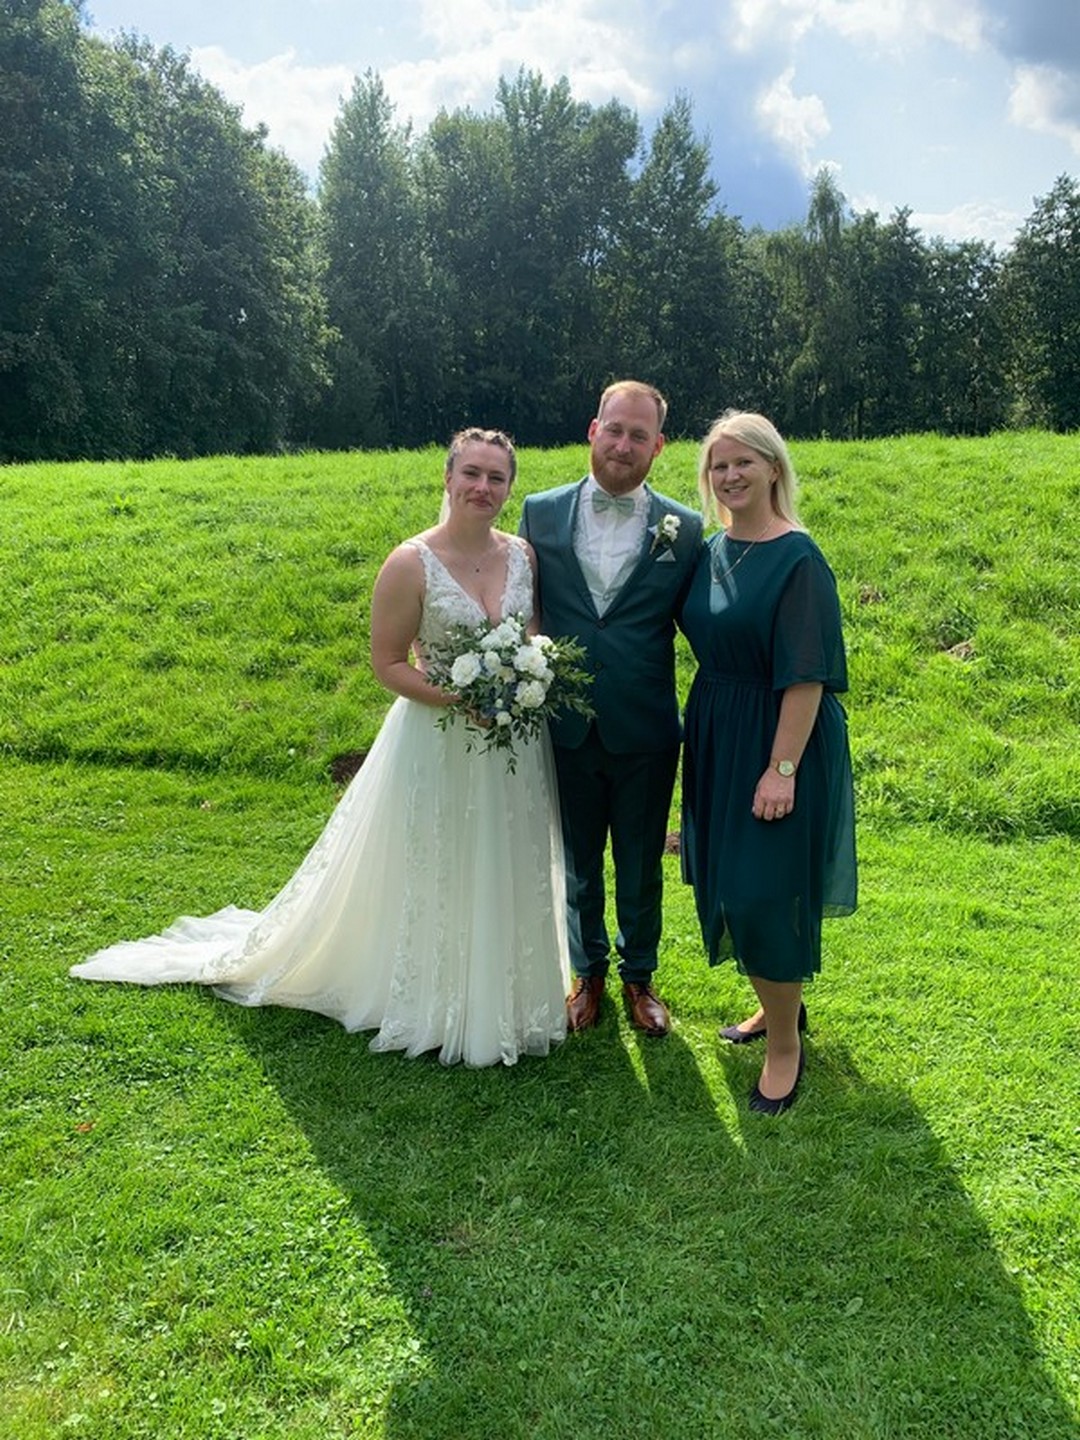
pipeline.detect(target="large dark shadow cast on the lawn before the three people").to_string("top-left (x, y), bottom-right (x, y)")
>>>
top-left (216, 1007), bottom-right (1080, 1440)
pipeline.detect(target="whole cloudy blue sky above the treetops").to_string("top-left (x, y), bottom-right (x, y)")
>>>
top-left (84, 0), bottom-right (1080, 245)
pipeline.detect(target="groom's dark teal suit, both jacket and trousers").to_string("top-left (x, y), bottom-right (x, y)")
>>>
top-left (520, 481), bottom-right (701, 984)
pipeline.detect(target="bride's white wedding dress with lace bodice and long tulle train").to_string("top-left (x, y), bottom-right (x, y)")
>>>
top-left (71, 539), bottom-right (569, 1066)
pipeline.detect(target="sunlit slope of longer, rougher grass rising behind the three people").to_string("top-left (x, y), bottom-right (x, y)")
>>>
top-left (0, 433), bottom-right (1080, 838)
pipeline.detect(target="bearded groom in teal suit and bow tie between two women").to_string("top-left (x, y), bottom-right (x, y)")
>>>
top-left (520, 380), bottom-right (701, 1035)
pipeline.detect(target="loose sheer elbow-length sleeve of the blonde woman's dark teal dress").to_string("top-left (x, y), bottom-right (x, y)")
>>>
top-left (772, 547), bottom-right (848, 691)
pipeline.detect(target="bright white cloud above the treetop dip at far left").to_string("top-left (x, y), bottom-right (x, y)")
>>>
top-left (192, 45), bottom-right (354, 177)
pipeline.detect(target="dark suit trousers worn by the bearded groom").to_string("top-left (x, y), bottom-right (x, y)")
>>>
top-left (554, 724), bottom-right (678, 984)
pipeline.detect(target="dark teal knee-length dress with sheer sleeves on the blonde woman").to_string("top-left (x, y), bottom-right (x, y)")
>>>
top-left (680, 531), bottom-right (857, 981)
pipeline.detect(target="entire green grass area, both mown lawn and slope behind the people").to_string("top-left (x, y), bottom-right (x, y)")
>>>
top-left (0, 433), bottom-right (1080, 1440)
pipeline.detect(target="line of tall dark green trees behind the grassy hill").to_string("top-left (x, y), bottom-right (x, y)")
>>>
top-left (0, 0), bottom-right (1080, 461)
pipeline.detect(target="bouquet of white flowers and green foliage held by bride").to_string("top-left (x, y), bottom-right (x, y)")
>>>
top-left (425, 615), bottom-right (593, 770)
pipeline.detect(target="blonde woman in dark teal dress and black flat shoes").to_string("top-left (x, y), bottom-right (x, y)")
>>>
top-left (681, 410), bottom-right (855, 1115)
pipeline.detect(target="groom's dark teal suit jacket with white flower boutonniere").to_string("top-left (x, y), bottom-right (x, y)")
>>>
top-left (520, 480), bottom-right (701, 755)
